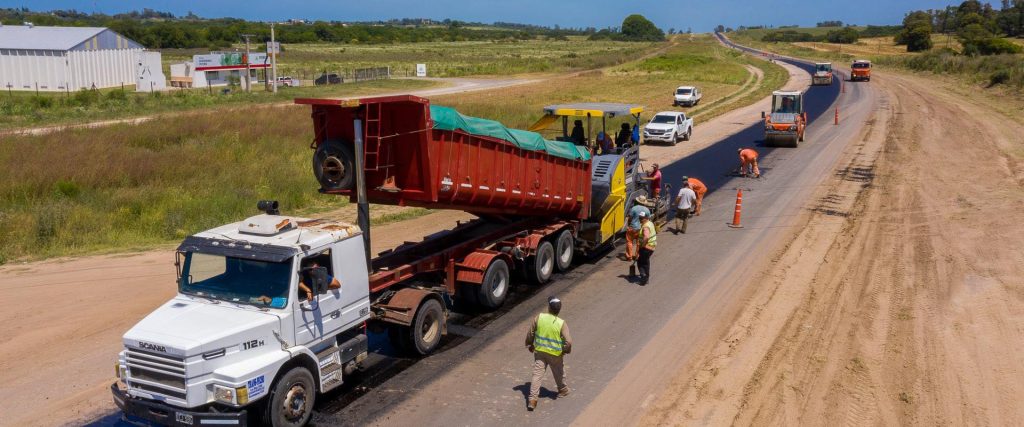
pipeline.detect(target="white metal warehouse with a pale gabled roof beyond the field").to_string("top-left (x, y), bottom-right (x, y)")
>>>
top-left (0, 25), bottom-right (150, 92)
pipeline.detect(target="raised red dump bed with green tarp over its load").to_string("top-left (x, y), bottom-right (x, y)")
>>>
top-left (296, 95), bottom-right (591, 219)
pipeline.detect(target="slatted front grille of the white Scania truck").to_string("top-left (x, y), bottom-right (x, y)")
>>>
top-left (125, 348), bottom-right (185, 399)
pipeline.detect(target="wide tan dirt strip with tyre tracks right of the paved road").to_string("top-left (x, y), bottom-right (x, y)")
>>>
top-left (640, 69), bottom-right (1024, 425)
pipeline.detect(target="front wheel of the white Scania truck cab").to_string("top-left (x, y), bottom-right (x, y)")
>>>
top-left (264, 367), bottom-right (316, 427)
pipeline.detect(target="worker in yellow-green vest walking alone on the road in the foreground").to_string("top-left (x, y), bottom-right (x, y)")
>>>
top-left (526, 297), bottom-right (572, 411)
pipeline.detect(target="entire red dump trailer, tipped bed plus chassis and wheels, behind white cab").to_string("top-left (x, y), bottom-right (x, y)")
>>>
top-left (296, 95), bottom-right (667, 354)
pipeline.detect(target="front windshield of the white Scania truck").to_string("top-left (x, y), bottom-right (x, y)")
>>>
top-left (178, 252), bottom-right (292, 308)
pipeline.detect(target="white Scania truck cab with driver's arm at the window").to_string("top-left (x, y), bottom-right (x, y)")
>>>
top-left (112, 202), bottom-right (371, 426)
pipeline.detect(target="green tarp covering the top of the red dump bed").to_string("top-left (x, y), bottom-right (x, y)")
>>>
top-left (430, 105), bottom-right (590, 160)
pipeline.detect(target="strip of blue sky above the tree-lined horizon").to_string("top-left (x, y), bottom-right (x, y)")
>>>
top-left (12, 0), bottom-right (962, 32)
